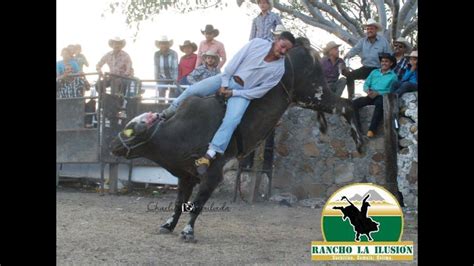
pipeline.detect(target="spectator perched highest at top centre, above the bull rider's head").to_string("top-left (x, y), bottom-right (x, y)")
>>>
top-left (249, 0), bottom-right (282, 41)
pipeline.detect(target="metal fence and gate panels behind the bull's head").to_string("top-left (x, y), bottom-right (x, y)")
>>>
top-left (56, 73), bottom-right (188, 193)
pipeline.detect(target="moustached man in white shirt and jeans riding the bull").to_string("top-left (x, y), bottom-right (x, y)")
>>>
top-left (160, 32), bottom-right (295, 174)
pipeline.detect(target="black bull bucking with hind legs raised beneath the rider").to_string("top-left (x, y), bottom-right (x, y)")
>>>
top-left (111, 40), bottom-right (362, 241)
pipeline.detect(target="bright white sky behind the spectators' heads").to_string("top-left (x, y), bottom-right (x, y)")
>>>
top-left (56, 0), bottom-right (364, 96)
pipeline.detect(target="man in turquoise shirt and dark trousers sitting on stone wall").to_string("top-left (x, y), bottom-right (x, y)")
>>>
top-left (352, 53), bottom-right (397, 138)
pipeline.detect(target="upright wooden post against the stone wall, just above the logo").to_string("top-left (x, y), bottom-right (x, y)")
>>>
top-left (383, 93), bottom-right (403, 206)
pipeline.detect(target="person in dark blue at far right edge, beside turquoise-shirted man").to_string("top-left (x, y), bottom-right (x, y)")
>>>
top-left (391, 51), bottom-right (418, 98)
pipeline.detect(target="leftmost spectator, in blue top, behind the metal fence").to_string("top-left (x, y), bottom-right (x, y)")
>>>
top-left (56, 48), bottom-right (85, 98)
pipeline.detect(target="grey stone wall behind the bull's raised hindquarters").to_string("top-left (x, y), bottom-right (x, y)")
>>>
top-left (219, 93), bottom-right (418, 208)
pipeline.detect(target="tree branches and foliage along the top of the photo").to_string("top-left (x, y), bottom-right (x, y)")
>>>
top-left (108, 0), bottom-right (418, 46)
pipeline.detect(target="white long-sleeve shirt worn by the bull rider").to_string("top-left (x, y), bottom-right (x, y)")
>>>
top-left (221, 38), bottom-right (285, 100)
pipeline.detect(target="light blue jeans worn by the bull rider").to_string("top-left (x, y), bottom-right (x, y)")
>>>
top-left (172, 75), bottom-right (250, 154)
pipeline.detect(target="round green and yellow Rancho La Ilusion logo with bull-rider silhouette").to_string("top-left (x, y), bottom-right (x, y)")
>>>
top-left (311, 183), bottom-right (413, 260)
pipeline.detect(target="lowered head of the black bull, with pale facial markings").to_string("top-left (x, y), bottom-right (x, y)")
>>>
top-left (110, 112), bottom-right (158, 159)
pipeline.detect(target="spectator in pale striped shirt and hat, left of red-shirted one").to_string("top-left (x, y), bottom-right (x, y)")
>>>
top-left (154, 35), bottom-right (179, 101)
